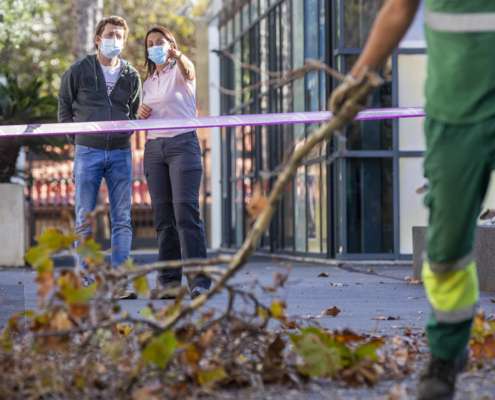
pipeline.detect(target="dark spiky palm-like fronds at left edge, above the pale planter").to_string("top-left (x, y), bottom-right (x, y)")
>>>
top-left (0, 76), bottom-right (66, 183)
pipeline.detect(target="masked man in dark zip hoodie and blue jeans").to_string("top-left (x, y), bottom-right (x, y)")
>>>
top-left (58, 16), bottom-right (142, 299)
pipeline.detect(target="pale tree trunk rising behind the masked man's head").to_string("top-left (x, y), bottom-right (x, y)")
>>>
top-left (72, 0), bottom-right (103, 61)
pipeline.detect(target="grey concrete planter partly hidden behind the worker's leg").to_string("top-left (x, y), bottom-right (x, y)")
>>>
top-left (413, 225), bottom-right (495, 292)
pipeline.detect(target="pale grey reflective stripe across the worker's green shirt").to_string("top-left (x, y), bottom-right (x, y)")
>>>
top-left (425, 10), bottom-right (495, 33)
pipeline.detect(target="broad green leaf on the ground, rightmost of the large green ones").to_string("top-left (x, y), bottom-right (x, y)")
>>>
top-left (294, 333), bottom-right (341, 378)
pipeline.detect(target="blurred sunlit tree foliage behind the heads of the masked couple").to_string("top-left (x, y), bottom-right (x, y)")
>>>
top-left (0, 0), bottom-right (207, 94)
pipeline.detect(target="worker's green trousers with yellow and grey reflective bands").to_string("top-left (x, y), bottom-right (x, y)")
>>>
top-left (423, 117), bottom-right (495, 360)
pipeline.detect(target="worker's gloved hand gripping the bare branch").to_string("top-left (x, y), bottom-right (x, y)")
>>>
top-left (328, 74), bottom-right (368, 120)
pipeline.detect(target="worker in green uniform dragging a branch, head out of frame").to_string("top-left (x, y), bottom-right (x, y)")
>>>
top-left (330, 0), bottom-right (495, 400)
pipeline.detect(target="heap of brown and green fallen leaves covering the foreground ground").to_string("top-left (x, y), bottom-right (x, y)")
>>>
top-left (0, 227), bottom-right (400, 399)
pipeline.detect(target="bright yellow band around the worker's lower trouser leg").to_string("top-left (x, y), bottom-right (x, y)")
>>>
top-left (422, 261), bottom-right (479, 313)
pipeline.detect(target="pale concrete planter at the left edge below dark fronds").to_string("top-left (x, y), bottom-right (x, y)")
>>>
top-left (0, 183), bottom-right (26, 267)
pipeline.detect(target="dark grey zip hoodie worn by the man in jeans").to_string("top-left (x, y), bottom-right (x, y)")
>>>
top-left (58, 54), bottom-right (142, 150)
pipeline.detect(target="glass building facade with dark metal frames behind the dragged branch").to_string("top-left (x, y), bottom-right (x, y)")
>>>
top-left (208, 0), bottom-right (426, 260)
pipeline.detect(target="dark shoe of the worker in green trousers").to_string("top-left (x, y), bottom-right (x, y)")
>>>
top-left (418, 350), bottom-right (468, 400)
